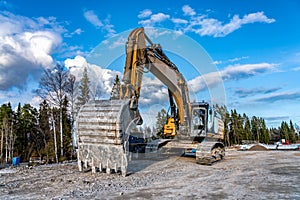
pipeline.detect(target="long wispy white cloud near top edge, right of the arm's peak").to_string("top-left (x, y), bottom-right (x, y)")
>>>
top-left (138, 5), bottom-right (275, 37)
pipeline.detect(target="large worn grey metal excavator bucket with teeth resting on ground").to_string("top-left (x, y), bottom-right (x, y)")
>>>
top-left (76, 100), bottom-right (135, 176)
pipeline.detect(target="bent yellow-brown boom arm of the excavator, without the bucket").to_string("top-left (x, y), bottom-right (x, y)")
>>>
top-left (119, 28), bottom-right (191, 126)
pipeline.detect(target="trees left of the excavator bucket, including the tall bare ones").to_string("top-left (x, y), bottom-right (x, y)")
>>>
top-left (0, 65), bottom-right (90, 163)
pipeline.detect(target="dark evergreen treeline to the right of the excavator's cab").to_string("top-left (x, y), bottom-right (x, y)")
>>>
top-left (215, 105), bottom-right (300, 146)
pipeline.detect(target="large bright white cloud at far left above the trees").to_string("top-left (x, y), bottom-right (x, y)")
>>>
top-left (0, 12), bottom-right (65, 90)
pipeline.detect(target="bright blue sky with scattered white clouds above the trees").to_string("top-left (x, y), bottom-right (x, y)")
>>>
top-left (0, 0), bottom-right (300, 127)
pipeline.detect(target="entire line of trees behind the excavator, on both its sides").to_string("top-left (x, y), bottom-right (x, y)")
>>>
top-left (0, 65), bottom-right (299, 163)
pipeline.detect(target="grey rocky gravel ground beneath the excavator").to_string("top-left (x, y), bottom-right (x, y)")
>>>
top-left (0, 150), bottom-right (300, 199)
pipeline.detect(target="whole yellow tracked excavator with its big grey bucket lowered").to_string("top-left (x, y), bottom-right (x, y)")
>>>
top-left (76, 28), bottom-right (225, 176)
